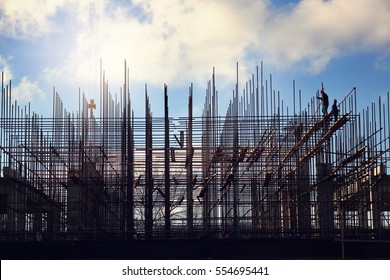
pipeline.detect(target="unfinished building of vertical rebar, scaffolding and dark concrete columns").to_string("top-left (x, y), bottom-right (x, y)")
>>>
top-left (0, 63), bottom-right (390, 258)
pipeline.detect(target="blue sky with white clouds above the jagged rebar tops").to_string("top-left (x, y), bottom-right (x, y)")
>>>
top-left (0, 0), bottom-right (390, 116)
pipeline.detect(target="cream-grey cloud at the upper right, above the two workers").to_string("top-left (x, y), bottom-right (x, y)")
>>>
top-left (260, 0), bottom-right (390, 73)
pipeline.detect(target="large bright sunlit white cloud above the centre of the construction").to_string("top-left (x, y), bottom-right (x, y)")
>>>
top-left (42, 0), bottom-right (266, 95)
